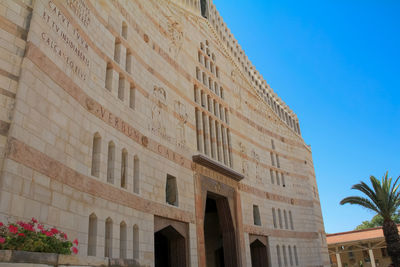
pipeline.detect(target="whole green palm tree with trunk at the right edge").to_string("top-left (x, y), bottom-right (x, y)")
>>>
top-left (340, 172), bottom-right (400, 267)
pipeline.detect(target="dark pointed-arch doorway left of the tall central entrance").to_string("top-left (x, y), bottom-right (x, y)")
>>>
top-left (154, 226), bottom-right (186, 267)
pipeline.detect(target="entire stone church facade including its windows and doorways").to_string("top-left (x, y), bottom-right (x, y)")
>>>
top-left (0, 0), bottom-right (329, 267)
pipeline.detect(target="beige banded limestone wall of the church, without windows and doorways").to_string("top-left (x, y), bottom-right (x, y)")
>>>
top-left (0, 0), bottom-right (329, 266)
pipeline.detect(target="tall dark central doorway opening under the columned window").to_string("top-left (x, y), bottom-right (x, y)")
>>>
top-left (204, 193), bottom-right (238, 267)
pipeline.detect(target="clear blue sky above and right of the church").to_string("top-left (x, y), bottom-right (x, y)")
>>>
top-left (214, 0), bottom-right (400, 233)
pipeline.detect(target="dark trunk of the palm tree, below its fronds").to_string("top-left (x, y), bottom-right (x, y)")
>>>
top-left (383, 219), bottom-right (400, 267)
